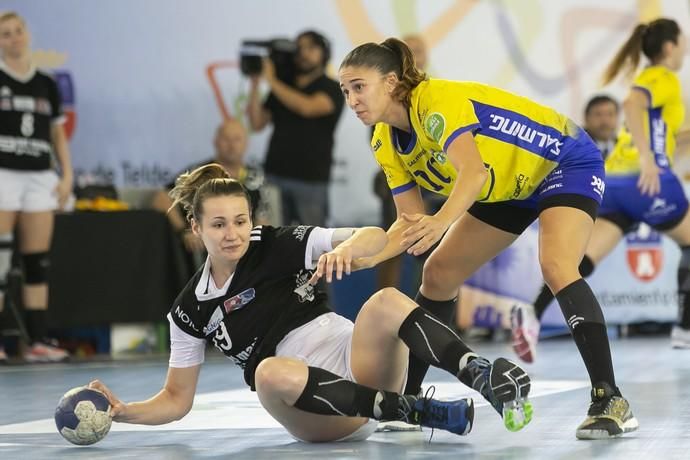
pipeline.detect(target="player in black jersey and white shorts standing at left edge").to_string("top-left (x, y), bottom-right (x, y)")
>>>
top-left (0, 12), bottom-right (72, 362)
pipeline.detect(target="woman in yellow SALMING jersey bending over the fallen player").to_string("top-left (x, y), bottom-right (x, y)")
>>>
top-left (340, 38), bottom-right (638, 439)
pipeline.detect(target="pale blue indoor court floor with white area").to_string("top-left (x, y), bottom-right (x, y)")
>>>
top-left (0, 337), bottom-right (690, 460)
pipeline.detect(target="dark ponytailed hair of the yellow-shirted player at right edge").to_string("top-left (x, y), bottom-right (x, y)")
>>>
top-left (603, 18), bottom-right (680, 84)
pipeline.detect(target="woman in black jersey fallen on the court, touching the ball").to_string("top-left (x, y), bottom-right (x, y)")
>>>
top-left (90, 164), bottom-right (531, 442)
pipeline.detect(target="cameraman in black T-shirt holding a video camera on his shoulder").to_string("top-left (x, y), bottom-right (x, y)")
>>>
top-left (248, 31), bottom-right (344, 226)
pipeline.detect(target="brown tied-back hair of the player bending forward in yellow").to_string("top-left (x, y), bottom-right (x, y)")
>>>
top-left (340, 38), bottom-right (427, 106)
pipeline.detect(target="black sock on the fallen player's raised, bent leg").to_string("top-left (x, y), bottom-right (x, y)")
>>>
top-left (398, 308), bottom-right (474, 383)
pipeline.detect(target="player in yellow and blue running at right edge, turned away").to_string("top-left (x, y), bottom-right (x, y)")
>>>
top-left (511, 18), bottom-right (690, 361)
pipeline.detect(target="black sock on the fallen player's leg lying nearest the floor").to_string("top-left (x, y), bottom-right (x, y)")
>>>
top-left (294, 366), bottom-right (408, 421)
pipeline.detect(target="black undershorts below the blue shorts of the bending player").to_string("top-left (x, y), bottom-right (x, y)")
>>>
top-left (467, 194), bottom-right (599, 235)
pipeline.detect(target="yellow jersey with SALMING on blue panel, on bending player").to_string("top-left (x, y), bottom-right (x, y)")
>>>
top-left (371, 79), bottom-right (585, 202)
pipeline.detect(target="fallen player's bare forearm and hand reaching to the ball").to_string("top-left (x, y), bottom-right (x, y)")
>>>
top-left (89, 365), bottom-right (201, 425)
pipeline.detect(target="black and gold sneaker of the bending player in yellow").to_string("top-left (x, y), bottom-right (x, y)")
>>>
top-left (575, 382), bottom-right (639, 439)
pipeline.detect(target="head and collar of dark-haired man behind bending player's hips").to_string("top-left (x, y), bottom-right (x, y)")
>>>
top-left (584, 94), bottom-right (620, 160)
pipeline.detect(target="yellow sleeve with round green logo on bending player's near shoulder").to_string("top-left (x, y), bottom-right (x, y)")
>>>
top-left (418, 85), bottom-right (481, 152)
